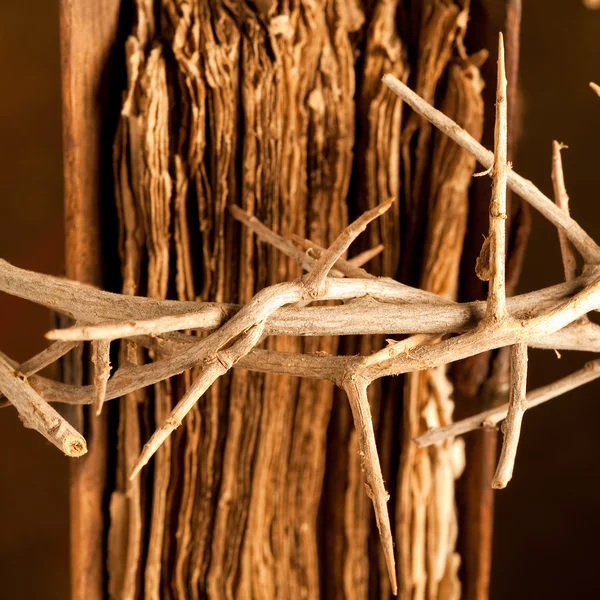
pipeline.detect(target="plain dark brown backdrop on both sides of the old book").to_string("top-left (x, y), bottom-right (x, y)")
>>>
top-left (0, 0), bottom-right (600, 600)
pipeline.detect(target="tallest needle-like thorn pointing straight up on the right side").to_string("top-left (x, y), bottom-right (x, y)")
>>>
top-left (486, 34), bottom-right (509, 324)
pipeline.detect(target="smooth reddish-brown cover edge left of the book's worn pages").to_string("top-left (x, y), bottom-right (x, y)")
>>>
top-left (60, 0), bottom-right (120, 600)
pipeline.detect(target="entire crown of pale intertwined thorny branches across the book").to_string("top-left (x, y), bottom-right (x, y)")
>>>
top-left (0, 37), bottom-right (600, 592)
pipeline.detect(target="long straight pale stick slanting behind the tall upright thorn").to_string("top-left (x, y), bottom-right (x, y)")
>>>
top-left (382, 74), bottom-right (600, 264)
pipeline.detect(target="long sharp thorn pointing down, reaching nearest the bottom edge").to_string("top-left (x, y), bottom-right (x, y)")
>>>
top-left (342, 374), bottom-right (398, 595)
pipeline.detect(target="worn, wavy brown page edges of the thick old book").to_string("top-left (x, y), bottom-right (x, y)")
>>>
top-left (51, 0), bottom-right (520, 598)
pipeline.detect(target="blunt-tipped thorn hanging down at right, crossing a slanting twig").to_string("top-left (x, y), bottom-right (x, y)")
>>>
top-left (492, 344), bottom-right (527, 490)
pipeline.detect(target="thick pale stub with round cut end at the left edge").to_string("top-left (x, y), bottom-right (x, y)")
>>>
top-left (0, 357), bottom-right (87, 456)
